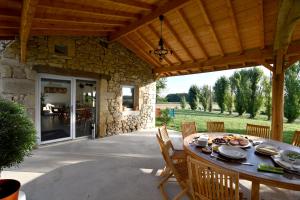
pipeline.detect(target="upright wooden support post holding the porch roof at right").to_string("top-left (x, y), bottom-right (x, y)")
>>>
top-left (272, 54), bottom-right (284, 141)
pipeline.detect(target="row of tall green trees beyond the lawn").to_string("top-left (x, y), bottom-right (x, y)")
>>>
top-left (158, 62), bottom-right (300, 123)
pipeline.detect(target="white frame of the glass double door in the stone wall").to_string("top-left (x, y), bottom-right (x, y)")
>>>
top-left (35, 73), bottom-right (99, 144)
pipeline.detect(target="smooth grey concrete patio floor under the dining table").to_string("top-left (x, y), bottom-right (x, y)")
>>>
top-left (1, 130), bottom-right (300, 200)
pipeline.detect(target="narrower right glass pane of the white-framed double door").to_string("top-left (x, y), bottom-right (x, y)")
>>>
top-left (76, 80), bottom-right (96, 137)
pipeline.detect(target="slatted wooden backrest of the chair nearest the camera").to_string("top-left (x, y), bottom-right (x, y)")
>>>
top-left (187, 156), bottom-right (239, 200)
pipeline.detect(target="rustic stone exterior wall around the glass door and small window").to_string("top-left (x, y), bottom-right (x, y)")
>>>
top-left (0, 36), bottom-right (156, 137)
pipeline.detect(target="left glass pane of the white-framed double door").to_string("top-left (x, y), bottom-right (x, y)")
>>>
top-left (41, 78), bottom-right (71, 142)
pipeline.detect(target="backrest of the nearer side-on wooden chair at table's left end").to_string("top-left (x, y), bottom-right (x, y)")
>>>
top-left (156, 134), bottom-right (184, 181)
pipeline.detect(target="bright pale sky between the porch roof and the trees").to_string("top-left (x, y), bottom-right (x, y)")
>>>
top-left (161, 66), bottom-right (270, 97)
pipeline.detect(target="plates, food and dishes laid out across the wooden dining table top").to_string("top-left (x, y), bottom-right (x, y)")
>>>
top-left (189, 133), bottom-right (300, 175)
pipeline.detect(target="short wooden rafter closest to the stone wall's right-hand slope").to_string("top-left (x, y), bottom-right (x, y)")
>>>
top-left (122, 37), bottom-right (161, 67)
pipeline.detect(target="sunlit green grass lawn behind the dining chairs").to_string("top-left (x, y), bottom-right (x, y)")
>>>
top-left (156, 109), bottom-right (300, 143)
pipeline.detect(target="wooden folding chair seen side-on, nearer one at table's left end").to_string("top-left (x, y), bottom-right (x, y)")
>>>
top-left (156, 134), bottom-right (191, 200)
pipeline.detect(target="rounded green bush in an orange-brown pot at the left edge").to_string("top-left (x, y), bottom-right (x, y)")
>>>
top-left (0, 98), bottom-right (36, 200)
